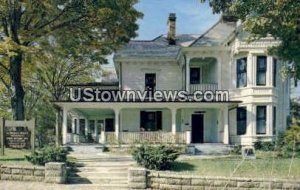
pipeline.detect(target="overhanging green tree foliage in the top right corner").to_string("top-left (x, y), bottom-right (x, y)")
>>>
top-left (200, 0), bottom-right (300, 84)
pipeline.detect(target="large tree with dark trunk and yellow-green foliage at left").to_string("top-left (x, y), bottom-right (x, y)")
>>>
top-left (0, 0), bottom-right (142, 120)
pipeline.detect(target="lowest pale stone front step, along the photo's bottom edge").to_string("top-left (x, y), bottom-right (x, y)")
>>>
top-left (66, 184), bottom-right (129, 190)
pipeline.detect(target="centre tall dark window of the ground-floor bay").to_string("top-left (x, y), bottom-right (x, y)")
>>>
top-left (256, 106), bottom-right (267, 135)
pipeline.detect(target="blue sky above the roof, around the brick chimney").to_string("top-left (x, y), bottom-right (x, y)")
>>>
top-left (135, 0), bottom-right (220, 40)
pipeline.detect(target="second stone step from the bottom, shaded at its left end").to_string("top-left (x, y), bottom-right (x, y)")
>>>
top-left (68, 176), bottom-right (128, 185)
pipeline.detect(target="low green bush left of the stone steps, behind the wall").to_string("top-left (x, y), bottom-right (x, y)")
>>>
top-left (25, 146), bottom-right (68, 165)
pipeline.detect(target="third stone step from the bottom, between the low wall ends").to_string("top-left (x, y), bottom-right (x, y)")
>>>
top-left (69, 170), bottom-right (128, 178)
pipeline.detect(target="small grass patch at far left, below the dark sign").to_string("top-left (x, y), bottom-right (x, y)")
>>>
top-left (0, 148), bottom-right (31, 165)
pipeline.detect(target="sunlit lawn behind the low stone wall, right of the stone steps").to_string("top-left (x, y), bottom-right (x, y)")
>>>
top-left (172, 152), bottom-right (300, 179)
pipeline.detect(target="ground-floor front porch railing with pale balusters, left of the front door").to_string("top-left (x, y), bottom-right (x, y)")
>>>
top-left (105, 131), bottom-right (187, 144)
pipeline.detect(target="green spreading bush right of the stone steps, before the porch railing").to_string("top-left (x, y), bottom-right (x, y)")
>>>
top-left (132, 144), bottom-right (181, 170)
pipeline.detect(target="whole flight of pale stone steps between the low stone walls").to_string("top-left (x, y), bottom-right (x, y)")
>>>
top-left (68, 152), bottom-right (135, 190)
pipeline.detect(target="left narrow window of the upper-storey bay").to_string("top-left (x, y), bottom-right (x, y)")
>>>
top-left (236, 57), bottom-right (247, 88)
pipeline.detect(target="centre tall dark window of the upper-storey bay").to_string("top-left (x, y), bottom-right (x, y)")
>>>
top-left (256, 56), bottom-right (267, 86)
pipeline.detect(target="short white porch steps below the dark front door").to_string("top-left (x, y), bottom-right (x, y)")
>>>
top-left (192, 143), bottom-right (232, 155)
